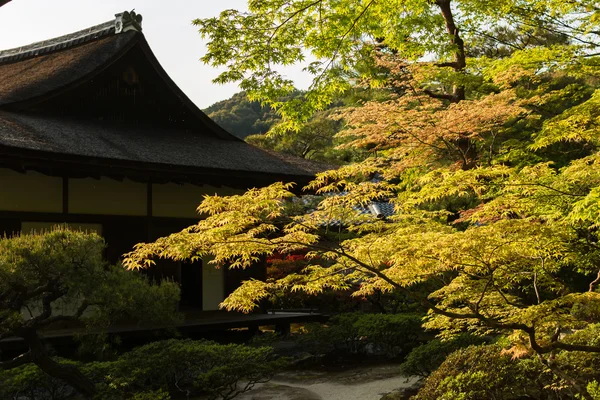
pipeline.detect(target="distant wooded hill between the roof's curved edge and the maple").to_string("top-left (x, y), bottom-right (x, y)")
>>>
top-left (204, 92), bottom-right (280, 139)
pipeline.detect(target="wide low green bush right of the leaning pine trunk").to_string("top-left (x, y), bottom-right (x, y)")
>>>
top-left (98, 339), bottom-right (285, 400)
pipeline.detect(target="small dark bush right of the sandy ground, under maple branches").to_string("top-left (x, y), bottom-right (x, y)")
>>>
top-left (401, 334), bottom-right (485, 378)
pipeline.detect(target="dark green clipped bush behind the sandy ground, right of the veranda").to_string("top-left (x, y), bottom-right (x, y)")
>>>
top-left (298, 313), bottom-right (423, 357)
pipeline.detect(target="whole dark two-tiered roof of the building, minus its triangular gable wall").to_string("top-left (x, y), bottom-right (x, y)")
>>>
top-left (0, 14), bottom-right (329, 181)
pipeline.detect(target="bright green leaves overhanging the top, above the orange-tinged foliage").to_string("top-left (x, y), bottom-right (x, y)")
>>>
top-left (194, 0), bottom-right (598, 130)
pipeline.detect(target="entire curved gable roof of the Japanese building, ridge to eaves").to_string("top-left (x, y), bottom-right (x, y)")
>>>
top-left (0, 15), bottom-right (328, 185)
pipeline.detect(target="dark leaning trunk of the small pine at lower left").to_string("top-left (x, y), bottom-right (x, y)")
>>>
top-left (19, 330), bottom-right (96, 399)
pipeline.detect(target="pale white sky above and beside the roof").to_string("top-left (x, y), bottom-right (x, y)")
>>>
top-left (0, 0), bottom-right (308, 108)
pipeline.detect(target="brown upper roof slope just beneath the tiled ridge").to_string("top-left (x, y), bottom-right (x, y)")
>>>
top-left (0, 32), bottom-right (135, 106)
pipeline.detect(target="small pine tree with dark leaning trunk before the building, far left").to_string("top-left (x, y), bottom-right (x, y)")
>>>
top-left (0, 228), bottom-right (179, 396)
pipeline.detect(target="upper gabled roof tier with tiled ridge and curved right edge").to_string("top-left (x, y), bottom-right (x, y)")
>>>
top-left (0, 14), bottom-right (241, 141)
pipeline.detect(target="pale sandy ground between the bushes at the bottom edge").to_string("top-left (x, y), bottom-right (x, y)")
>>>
top-left (232, 365), bottom-right (418, 400)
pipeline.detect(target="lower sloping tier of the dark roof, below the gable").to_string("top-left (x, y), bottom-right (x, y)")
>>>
top-left (0, 111), bottom-right (326, 177)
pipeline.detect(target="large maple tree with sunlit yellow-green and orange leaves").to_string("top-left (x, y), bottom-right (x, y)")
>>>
top-left (125, 0), bottom-right (600, 399)
